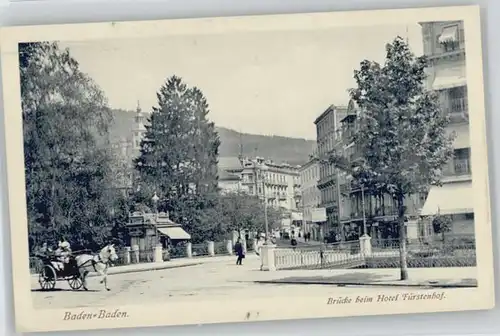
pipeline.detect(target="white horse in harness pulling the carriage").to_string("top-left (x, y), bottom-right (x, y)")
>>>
top-left (75, 244), bottom-right (118, 291)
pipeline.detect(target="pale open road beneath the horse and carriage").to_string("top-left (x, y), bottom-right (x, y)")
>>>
top-left (32, 256), bottom-right (422, 309)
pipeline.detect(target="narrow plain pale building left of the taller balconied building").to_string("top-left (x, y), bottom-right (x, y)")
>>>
top-left (299, 151), bottom-right (323, 240)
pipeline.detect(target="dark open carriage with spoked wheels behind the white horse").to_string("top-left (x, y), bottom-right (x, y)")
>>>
top-left (37, 250), bottom-right (89, 290)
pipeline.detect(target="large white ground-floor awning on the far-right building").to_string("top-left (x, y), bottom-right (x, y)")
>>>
top-left (420, 181), bottom-right (474, 216)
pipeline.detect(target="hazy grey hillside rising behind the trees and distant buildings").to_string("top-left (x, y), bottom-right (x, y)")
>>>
top-left (110, 110), bottom-right (315, 165)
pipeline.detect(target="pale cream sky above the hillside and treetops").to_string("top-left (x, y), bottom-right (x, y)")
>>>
top-left (60, 22), bottom-right (423, 139)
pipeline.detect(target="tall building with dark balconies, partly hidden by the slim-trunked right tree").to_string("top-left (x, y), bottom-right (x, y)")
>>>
top-left (314, 105), bottom-right (347, 238)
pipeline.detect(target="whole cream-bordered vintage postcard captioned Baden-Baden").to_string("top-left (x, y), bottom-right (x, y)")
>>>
top-left (1, 6), bottom-right (494, 331)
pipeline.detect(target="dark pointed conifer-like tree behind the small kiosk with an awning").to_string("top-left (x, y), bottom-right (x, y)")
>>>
top-left (135, 76), bottom-right (220, 242)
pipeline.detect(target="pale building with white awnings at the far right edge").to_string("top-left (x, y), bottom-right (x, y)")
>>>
top-left (420, 21), bottom-right (474, 237)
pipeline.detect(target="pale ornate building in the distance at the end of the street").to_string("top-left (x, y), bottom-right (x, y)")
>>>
top-left (241, 157), bottom-right (302, 231)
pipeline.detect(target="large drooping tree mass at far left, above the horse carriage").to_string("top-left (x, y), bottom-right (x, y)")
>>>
top-left (19, 42), bottom-right (111, 252)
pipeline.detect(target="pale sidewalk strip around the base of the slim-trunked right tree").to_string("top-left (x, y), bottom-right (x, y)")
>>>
top-left (236, 267), bottom-right (477, 288)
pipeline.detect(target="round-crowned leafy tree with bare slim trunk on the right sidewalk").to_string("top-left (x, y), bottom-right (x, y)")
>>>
top-left (327, 37), bottom-right (453, 280)
